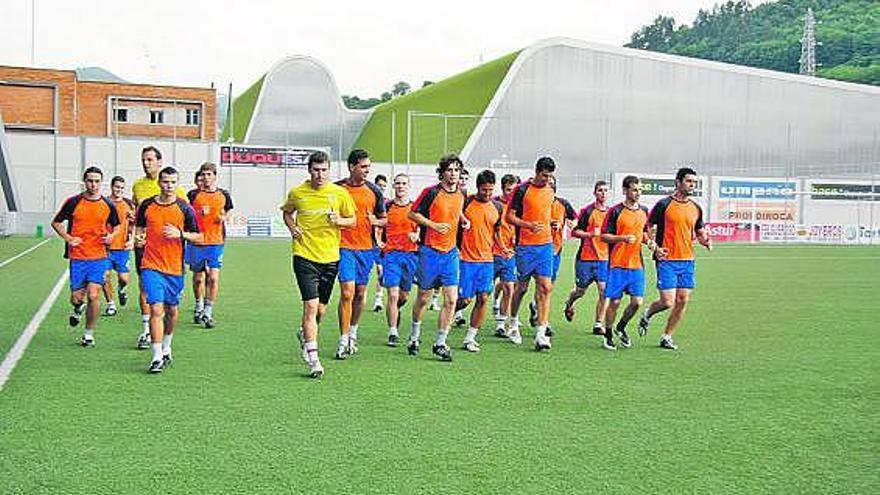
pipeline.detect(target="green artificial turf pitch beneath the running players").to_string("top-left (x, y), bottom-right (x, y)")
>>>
top-left (0, 240), bottom-right (880, 494)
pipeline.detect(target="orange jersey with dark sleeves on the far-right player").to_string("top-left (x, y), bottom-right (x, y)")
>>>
top-left (648, 196), bottom-right (703, 260)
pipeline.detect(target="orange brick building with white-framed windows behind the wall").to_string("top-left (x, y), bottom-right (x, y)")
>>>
top-left (0, 65), bottom-right (217, 141)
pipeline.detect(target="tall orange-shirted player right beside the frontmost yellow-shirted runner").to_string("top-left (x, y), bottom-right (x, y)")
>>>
top-left (336, 149), bottom-right (386, 359)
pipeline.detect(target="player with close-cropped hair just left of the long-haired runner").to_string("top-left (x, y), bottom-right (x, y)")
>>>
top-left (382, 174), bottom-right (419, 347)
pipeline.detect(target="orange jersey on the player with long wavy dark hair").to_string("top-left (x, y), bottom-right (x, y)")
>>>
top-left (412, 184), bottom-right (464, 253)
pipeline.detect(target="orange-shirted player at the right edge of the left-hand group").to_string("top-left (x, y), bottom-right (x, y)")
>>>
top-left (188, 162), bottom-right (233, 328)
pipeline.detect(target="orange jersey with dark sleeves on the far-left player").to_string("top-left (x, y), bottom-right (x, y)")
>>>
top-left (53, 194), bottom-right (119, 260)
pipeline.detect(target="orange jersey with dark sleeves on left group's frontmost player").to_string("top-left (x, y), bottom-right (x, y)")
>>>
top-left (136, 196), bottom-right (199, 275)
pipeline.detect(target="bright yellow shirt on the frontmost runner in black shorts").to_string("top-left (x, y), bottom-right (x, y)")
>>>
top-left (281, 181), bottom-right (355, 263)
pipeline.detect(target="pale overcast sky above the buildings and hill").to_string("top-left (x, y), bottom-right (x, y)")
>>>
top-left (0, 0), bottom-right (760, 97)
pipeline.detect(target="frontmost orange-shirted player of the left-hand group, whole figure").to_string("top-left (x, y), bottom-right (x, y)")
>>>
top-left (135, 167), bottom-right (203, 373)
